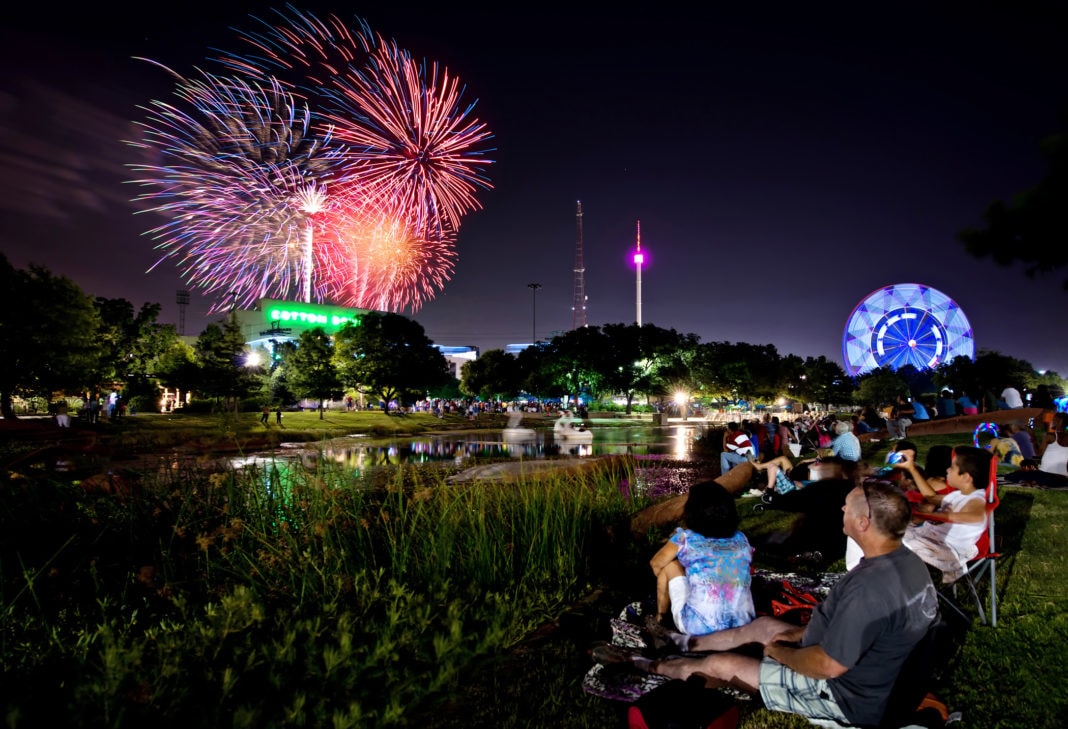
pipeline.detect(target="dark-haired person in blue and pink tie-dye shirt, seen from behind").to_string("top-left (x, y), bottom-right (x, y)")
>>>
top-left (649, 480), bottom-right (756, 635)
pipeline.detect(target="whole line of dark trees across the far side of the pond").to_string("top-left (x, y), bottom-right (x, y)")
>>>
top-left (0, 254), bottom-right (1064, 417)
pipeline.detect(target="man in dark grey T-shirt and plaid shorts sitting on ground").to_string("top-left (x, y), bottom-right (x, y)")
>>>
top-left (594, 479), bottom-right (938, 726)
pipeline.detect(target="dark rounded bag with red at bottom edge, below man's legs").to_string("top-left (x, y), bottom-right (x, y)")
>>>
top-left (627, 676), bottom-right (738, 729)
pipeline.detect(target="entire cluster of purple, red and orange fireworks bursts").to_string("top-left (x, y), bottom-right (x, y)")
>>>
top-left (132, 9), bottom-right (491, 312)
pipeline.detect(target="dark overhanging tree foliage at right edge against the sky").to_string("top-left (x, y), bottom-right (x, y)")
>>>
top-left (958, 121), bottom-right (1068, 290)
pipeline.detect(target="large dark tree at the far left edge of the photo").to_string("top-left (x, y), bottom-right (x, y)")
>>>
top-left (0, 254), bottom-right (100, 418)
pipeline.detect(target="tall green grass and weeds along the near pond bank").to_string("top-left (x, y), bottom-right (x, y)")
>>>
top-left (0, 452), bottom-right (635, 727)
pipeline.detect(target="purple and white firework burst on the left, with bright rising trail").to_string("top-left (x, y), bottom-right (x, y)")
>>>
top-left (131, 62), bottom-right (348, 310)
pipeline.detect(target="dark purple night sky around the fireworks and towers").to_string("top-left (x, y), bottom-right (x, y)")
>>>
top-left (0, 5), bottom-right (1068, 376)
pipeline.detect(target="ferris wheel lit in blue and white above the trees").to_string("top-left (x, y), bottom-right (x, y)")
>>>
top-left (842, 284), bottom-right (975, 377)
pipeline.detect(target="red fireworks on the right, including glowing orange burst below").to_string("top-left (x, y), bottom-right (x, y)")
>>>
top-left (219, 7), bottom-right (492, 303)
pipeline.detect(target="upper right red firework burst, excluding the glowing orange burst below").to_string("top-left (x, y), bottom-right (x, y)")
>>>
top-left (218, 5), bottom-right (492, 250)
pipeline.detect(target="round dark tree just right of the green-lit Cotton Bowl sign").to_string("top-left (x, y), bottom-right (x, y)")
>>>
top-left (334, 312), bottom-right (452, 414)
